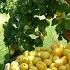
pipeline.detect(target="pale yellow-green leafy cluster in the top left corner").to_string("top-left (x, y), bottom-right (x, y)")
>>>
top-left (0, 0), bottom-right (17, 13)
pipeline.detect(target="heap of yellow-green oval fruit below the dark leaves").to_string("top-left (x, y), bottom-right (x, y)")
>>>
top-left (4, 44), bottom-right (70, 70)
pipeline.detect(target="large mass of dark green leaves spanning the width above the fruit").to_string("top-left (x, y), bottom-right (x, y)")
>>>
top-left (0, 0), bottom-right (70, 56)
